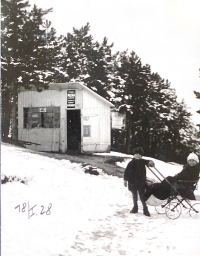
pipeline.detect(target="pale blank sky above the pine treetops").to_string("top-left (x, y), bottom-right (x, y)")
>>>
top-left (29, 0), bottom-right (200, 124)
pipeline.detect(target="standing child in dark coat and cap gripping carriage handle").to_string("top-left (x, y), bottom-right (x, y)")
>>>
top-left (124, 147), bottom-right (155, 216)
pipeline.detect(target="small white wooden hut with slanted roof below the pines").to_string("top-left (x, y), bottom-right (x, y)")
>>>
top-left (18, 83), bottom-right (113, 153)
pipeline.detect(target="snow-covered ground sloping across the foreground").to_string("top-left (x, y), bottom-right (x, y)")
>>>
top-left (1, 144), bottom-right (200, 256)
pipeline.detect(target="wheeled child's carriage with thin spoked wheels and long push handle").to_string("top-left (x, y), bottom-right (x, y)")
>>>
top-left (145, 167), bottom-right (200, 219)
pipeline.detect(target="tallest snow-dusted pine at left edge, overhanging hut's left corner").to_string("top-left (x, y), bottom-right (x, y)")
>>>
top-left (2, 0), bottom-right (59, 140)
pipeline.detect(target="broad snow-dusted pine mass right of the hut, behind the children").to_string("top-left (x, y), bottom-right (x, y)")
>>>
top-left (113, 51), bottom-right (198, 160)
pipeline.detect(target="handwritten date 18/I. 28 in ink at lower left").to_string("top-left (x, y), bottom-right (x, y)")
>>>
top-left (15, 202), bottom-right (52, 219)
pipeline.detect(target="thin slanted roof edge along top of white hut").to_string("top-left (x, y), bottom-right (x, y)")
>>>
top-left (20, 82), bottom-right (114, 107)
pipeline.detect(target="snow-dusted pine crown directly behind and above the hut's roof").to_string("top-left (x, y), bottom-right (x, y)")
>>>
top-left (57, 23), bottom-right (115, 99)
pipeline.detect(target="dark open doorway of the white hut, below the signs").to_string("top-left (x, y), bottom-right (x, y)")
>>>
top-left (67, 110), bottom-right (81, 150)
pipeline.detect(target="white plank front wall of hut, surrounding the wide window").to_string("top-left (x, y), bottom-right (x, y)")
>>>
top-left (18, 89), bottom-right (82, 152)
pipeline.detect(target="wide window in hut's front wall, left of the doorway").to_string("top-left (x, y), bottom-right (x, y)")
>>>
top-left (24, 107), bottom-right (60, 129)
